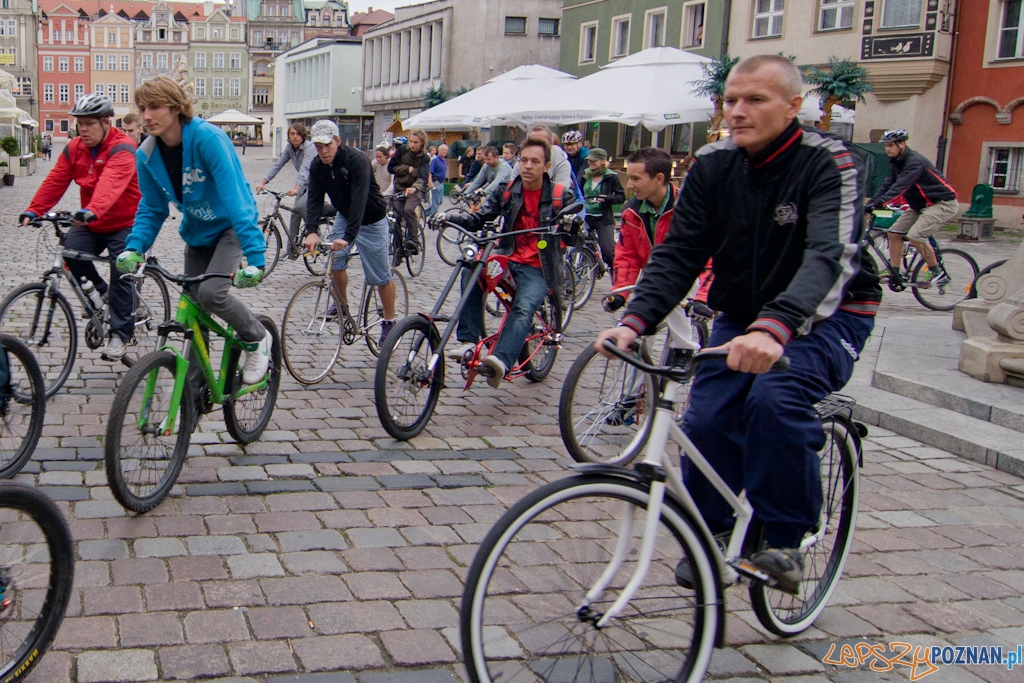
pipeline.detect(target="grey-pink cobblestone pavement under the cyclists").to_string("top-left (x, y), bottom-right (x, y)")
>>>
top-left (0, 141), bottom-right (1024, 683)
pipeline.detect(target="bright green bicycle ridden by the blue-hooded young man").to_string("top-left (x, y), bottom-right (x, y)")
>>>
top-left (103, 265), bottom-right (282, 512)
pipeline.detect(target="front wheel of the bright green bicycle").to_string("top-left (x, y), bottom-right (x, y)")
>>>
top-left (103, 351), bottom-right (198, 513)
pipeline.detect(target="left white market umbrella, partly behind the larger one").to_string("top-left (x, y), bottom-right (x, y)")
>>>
top-left (401, 65), bottom-right (575, 130)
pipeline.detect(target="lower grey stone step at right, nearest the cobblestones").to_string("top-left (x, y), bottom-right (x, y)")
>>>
top-left (843, 383), bottom-right (1024, 476)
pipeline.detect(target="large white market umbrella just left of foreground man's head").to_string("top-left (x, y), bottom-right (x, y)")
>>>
top-left (508, 47), bottom-right (715, 143)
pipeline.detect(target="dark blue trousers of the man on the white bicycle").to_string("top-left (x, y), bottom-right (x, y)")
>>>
top-left (683, 311), bottom-right (874, 548)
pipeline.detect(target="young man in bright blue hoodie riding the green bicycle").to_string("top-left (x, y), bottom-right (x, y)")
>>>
top-left (118, 76), bottom-right (272, 384)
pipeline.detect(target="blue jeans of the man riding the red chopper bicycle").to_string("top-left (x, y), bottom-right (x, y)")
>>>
top-left (456, 261), bottom-right (548, 370)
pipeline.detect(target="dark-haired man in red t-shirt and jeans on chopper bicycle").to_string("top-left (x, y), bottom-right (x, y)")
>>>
top-left (449, 139), bottom-right (573, 388)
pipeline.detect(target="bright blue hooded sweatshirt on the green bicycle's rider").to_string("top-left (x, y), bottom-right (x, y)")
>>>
top-left (126, 118), bottom-right (266, 268)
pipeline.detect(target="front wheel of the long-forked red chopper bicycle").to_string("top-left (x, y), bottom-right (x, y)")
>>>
top-left (374, 315), bottom-right (444, 441)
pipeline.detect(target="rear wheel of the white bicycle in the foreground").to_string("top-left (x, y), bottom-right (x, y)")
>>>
top-left (750, 418), bottom-right (860, 638)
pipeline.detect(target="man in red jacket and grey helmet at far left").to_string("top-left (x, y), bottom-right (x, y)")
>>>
top-left (22, 94), bottom-right (141, 360)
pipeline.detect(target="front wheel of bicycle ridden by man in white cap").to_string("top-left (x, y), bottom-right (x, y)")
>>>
top-left (281, 280), bottom-right (342, 384)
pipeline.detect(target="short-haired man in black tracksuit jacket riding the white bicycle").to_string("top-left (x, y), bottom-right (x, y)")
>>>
top-left (598, 55), bottom-right (882, 593)
